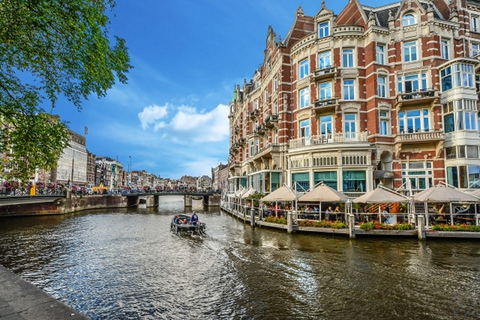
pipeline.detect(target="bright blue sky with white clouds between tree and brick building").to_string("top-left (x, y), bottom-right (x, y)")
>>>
top-left (54, 0), bottom-right (390, 179)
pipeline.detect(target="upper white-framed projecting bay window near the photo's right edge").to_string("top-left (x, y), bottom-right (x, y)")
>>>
top-left (440, 63), bottom-right (475, 91)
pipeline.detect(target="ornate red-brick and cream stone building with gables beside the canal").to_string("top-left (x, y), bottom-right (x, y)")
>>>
top-left (229, 0), bottom-right (480, 196)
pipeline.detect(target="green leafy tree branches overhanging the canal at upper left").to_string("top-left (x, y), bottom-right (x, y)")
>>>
top-left (0, 0), bottom-right (131, 183)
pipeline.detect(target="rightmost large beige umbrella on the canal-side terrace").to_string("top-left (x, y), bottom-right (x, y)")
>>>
top-left (413, 184), bottom-right (478, 226)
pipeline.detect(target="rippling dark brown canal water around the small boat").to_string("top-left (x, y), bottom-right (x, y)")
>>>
top-left (0, 197), bottom-right (480, 320)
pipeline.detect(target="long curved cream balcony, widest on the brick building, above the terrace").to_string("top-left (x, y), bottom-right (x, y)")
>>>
top-left (289, 131), bottom-right (368, 149)
